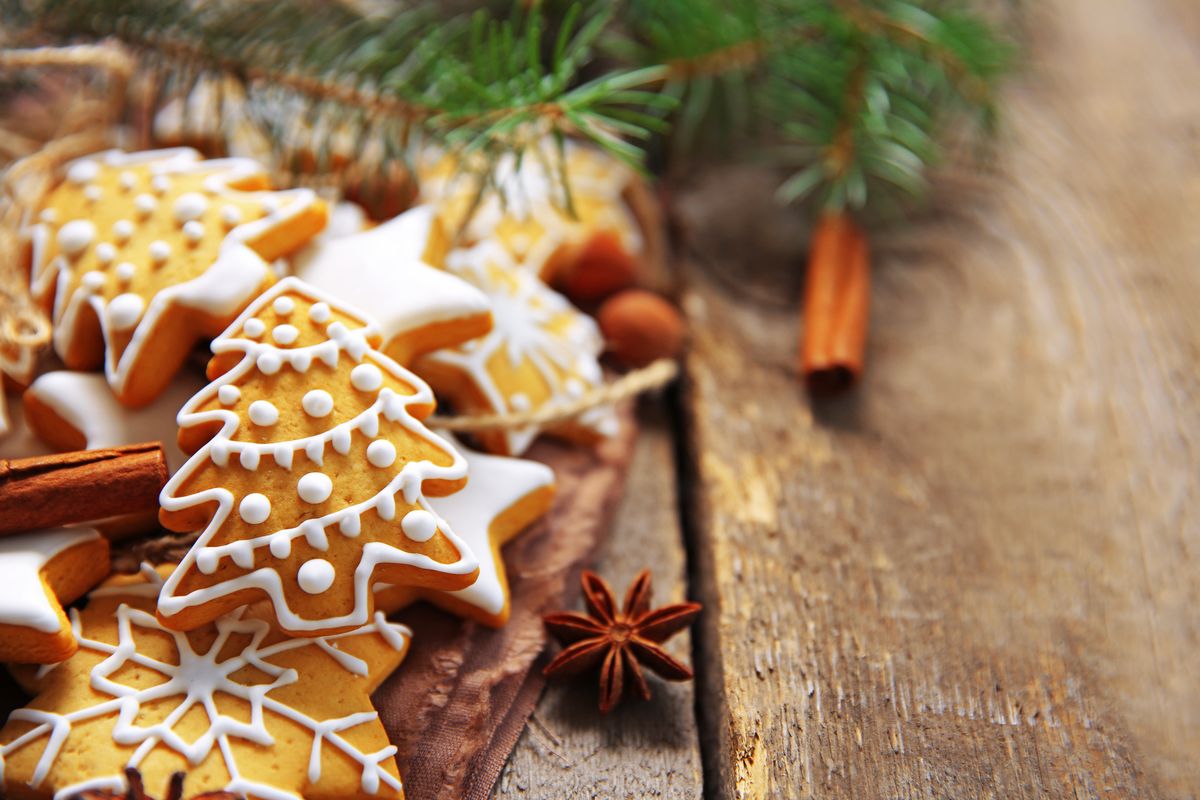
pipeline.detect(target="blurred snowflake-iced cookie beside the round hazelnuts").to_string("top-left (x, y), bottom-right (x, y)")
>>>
top-left (414, 241), bottom-right (617, 456)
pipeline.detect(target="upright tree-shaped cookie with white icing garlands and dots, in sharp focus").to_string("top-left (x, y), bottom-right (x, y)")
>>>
top-left (158, 277), bottom-right (478, 636)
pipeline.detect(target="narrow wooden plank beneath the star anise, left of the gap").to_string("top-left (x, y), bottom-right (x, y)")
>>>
top-left (494, 399), bottom-right (701, 800)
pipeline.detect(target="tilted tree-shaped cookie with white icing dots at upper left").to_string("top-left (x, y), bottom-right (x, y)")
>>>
top-left (30, 149), bottom-right (325, 407)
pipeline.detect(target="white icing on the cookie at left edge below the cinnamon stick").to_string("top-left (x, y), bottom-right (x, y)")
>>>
top-left (0, 528), bottom-right (100, 633)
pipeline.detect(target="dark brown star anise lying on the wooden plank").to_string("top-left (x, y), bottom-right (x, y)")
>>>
top-left (542, 570), bottom-right (700, 714)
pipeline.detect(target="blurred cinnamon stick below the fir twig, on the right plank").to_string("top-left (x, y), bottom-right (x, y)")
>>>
top-left (800, 213), bottom-right (871, 395)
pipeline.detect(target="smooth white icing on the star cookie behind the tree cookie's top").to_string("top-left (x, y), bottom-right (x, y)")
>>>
top-left (294, 207), bottom-right (488, 349)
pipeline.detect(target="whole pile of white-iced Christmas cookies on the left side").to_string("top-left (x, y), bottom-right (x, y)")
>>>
top-left (0, 149), bottom-right (640, 800)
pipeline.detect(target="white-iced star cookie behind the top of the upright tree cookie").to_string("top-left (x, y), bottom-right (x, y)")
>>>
top-left (295, 207), bottom-right (492, 363)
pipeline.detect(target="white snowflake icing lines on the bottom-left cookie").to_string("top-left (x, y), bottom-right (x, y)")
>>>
top-left (0, 566), bottom-right (412, 800)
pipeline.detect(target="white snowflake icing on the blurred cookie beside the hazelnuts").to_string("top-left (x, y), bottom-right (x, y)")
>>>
top-left (426, 241), bottom-right (617, 455)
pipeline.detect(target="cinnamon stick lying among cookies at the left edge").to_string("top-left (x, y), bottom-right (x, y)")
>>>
top-left (0, 441), bottom-right (167, 535)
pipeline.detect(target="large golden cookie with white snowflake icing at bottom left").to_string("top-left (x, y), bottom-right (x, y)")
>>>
top-left (0, 567), bottom-right (410, 800)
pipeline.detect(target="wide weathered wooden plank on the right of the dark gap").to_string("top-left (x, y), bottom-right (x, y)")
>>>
top-left (685, 0), bottom-right (1200, 799)
